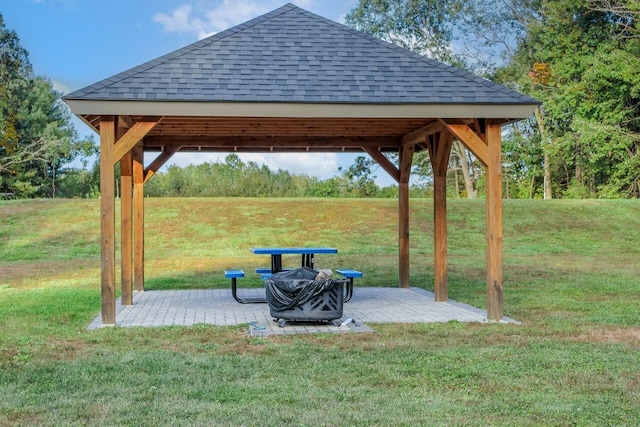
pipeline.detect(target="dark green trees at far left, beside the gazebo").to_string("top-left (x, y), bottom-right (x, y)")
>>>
top-left (0, 15), bottom-right (93, 197)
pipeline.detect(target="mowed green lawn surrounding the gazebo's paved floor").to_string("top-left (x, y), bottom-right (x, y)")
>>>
top-left (0, 198), bottom-right (640, 426)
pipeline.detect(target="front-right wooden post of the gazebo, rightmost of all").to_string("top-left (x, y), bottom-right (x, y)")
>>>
top-left (486, 120), bottom-right (504, 320)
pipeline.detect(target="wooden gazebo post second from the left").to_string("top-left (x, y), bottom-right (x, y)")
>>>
top-left (120, 151), bottom-right (133, 305)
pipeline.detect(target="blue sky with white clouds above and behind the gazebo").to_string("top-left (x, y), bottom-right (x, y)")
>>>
top-left (0, 0), bottom-right (404, 185)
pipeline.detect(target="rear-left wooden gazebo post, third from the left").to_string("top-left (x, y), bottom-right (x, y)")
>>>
top-left (133, 143), bottom-right (144, 291)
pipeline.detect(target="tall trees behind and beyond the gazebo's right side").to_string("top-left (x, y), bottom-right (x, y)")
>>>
top-left (346, 0), bottom-right (640, 198)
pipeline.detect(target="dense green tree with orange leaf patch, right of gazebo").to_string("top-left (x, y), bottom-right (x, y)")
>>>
top-left (498, 0), bottom-right (640, 197)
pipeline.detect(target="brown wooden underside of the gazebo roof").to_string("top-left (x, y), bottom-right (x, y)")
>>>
top-left (80, 116), bottom-right (433, 152)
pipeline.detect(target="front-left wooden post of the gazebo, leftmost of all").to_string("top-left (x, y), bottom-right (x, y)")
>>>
top-left (100, 117), bottom-right (116, 325)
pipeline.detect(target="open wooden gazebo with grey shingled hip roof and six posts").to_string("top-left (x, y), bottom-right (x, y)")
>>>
top-left (64, 4), bottom-right (538, 325)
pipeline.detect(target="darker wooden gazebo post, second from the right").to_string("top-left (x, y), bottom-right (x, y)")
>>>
top-left (429, 131), bottom-right (453, 302)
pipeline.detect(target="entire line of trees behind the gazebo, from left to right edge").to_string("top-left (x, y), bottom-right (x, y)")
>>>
top-left (0, 0), bottom-right (640, 198)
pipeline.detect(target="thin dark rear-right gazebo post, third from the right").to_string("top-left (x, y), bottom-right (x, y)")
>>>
top-left (398, 144), bottom-right (415, 288)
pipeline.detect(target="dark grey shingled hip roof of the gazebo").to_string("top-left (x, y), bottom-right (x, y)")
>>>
top-left (64, 4), bottom-right (538, 109)
